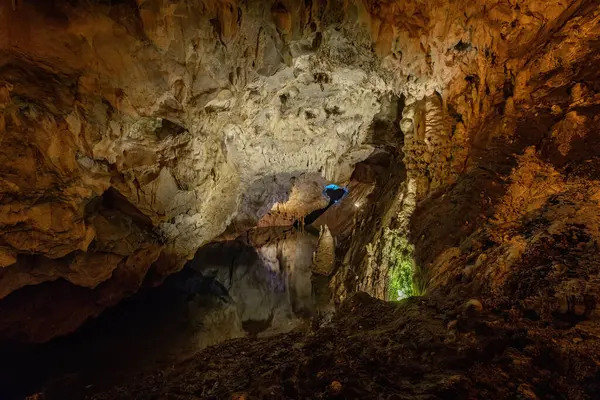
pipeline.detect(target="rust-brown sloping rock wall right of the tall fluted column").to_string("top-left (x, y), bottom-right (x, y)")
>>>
top-left (411, 2), bottom-right (600, 306)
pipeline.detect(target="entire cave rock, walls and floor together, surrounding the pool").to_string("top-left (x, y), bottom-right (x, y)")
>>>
top-left (0, 0), bottom-right (600, 399)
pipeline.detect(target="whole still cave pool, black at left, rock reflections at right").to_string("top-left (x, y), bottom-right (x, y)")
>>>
top-left (0, 228), bottom-right (328, 399)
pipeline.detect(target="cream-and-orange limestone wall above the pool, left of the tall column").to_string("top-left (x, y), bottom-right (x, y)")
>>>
top-left (0, 0), bottom-right (391, 336)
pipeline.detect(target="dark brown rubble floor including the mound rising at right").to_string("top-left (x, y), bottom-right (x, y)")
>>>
top-left (85, 219), bottom-right (600, 400)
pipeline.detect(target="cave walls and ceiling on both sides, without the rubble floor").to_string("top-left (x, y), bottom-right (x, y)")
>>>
top-left (0, 0), bottom-right (600, 346)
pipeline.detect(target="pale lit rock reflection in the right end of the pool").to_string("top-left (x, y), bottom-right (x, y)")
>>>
top-left (188, 228), bottom-right (318, 347)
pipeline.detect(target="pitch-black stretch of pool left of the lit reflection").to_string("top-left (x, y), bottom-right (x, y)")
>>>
top-left (0, 270), bottom-right (195, 400)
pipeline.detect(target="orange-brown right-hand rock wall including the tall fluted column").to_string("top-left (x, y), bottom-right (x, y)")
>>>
top-left (334, 1), bottom-right (599, 316)
